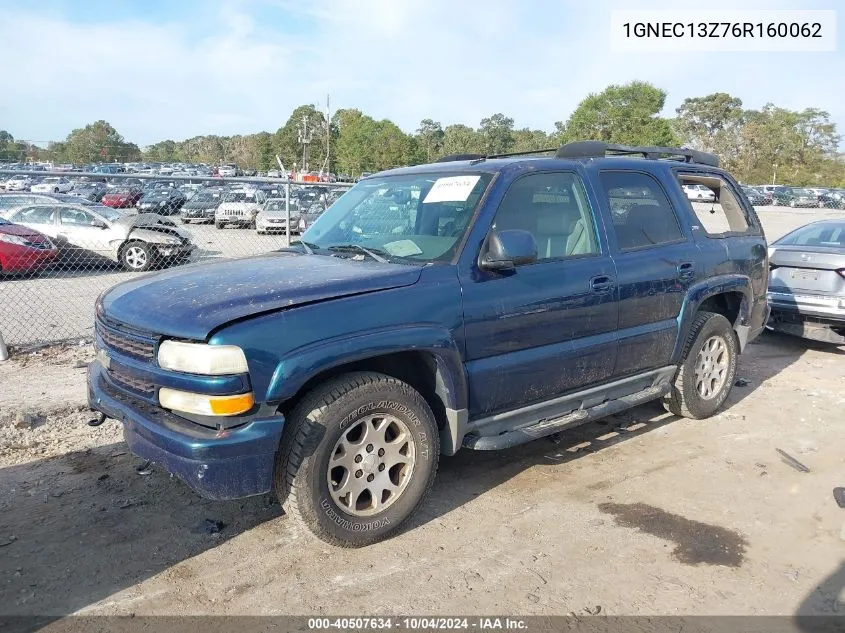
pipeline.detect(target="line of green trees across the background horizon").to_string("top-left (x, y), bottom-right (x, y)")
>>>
top-left (0, 81), bottom-right (845, 186)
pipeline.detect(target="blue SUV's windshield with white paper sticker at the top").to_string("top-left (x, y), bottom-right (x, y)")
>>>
top-left (302, 172), bottom-right (493, 262)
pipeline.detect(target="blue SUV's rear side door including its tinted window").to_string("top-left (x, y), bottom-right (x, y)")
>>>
top-left (598, 170), bottom-right (701, 378)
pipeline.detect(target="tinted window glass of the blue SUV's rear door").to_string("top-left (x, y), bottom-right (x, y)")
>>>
top-left (599, 171), bottom-right (684, 251)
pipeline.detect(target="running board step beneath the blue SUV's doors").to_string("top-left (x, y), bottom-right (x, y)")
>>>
top-left (463, 367), bottom-right (676, 451)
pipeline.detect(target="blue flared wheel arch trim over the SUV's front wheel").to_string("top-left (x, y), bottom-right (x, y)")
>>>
top-left (266, 325), bottom-right (467, 411)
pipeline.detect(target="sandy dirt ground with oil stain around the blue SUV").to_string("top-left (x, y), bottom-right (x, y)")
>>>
top-left (0, 334), bottom-right (845, 615)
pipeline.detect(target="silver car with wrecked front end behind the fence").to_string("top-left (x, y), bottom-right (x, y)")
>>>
top-left (4, 203), bottom-right (196, 272)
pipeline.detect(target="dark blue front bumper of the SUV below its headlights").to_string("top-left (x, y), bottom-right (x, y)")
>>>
top-left (88, 361), bottom-right (284, 500)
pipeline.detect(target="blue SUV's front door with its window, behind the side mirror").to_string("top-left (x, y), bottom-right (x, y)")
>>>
top-left (459, 172), bottom-right (618, 418)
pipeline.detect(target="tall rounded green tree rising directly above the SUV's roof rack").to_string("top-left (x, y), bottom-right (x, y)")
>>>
top-left (555, 81), bottom-right (679, 146)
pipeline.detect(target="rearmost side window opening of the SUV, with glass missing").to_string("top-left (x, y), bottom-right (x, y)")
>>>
top-left (678, 174), bottom-right (750, 237)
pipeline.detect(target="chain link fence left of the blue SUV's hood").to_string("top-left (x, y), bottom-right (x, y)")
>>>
top-left (0, 166), bottom-right (351, 348)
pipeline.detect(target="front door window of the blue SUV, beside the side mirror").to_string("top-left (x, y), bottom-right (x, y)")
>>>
top-left (493, 173), bottom-right (599, 260)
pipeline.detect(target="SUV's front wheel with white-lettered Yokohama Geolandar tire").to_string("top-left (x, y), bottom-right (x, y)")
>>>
top-left (275, 372), bottom-right (440, 547)
